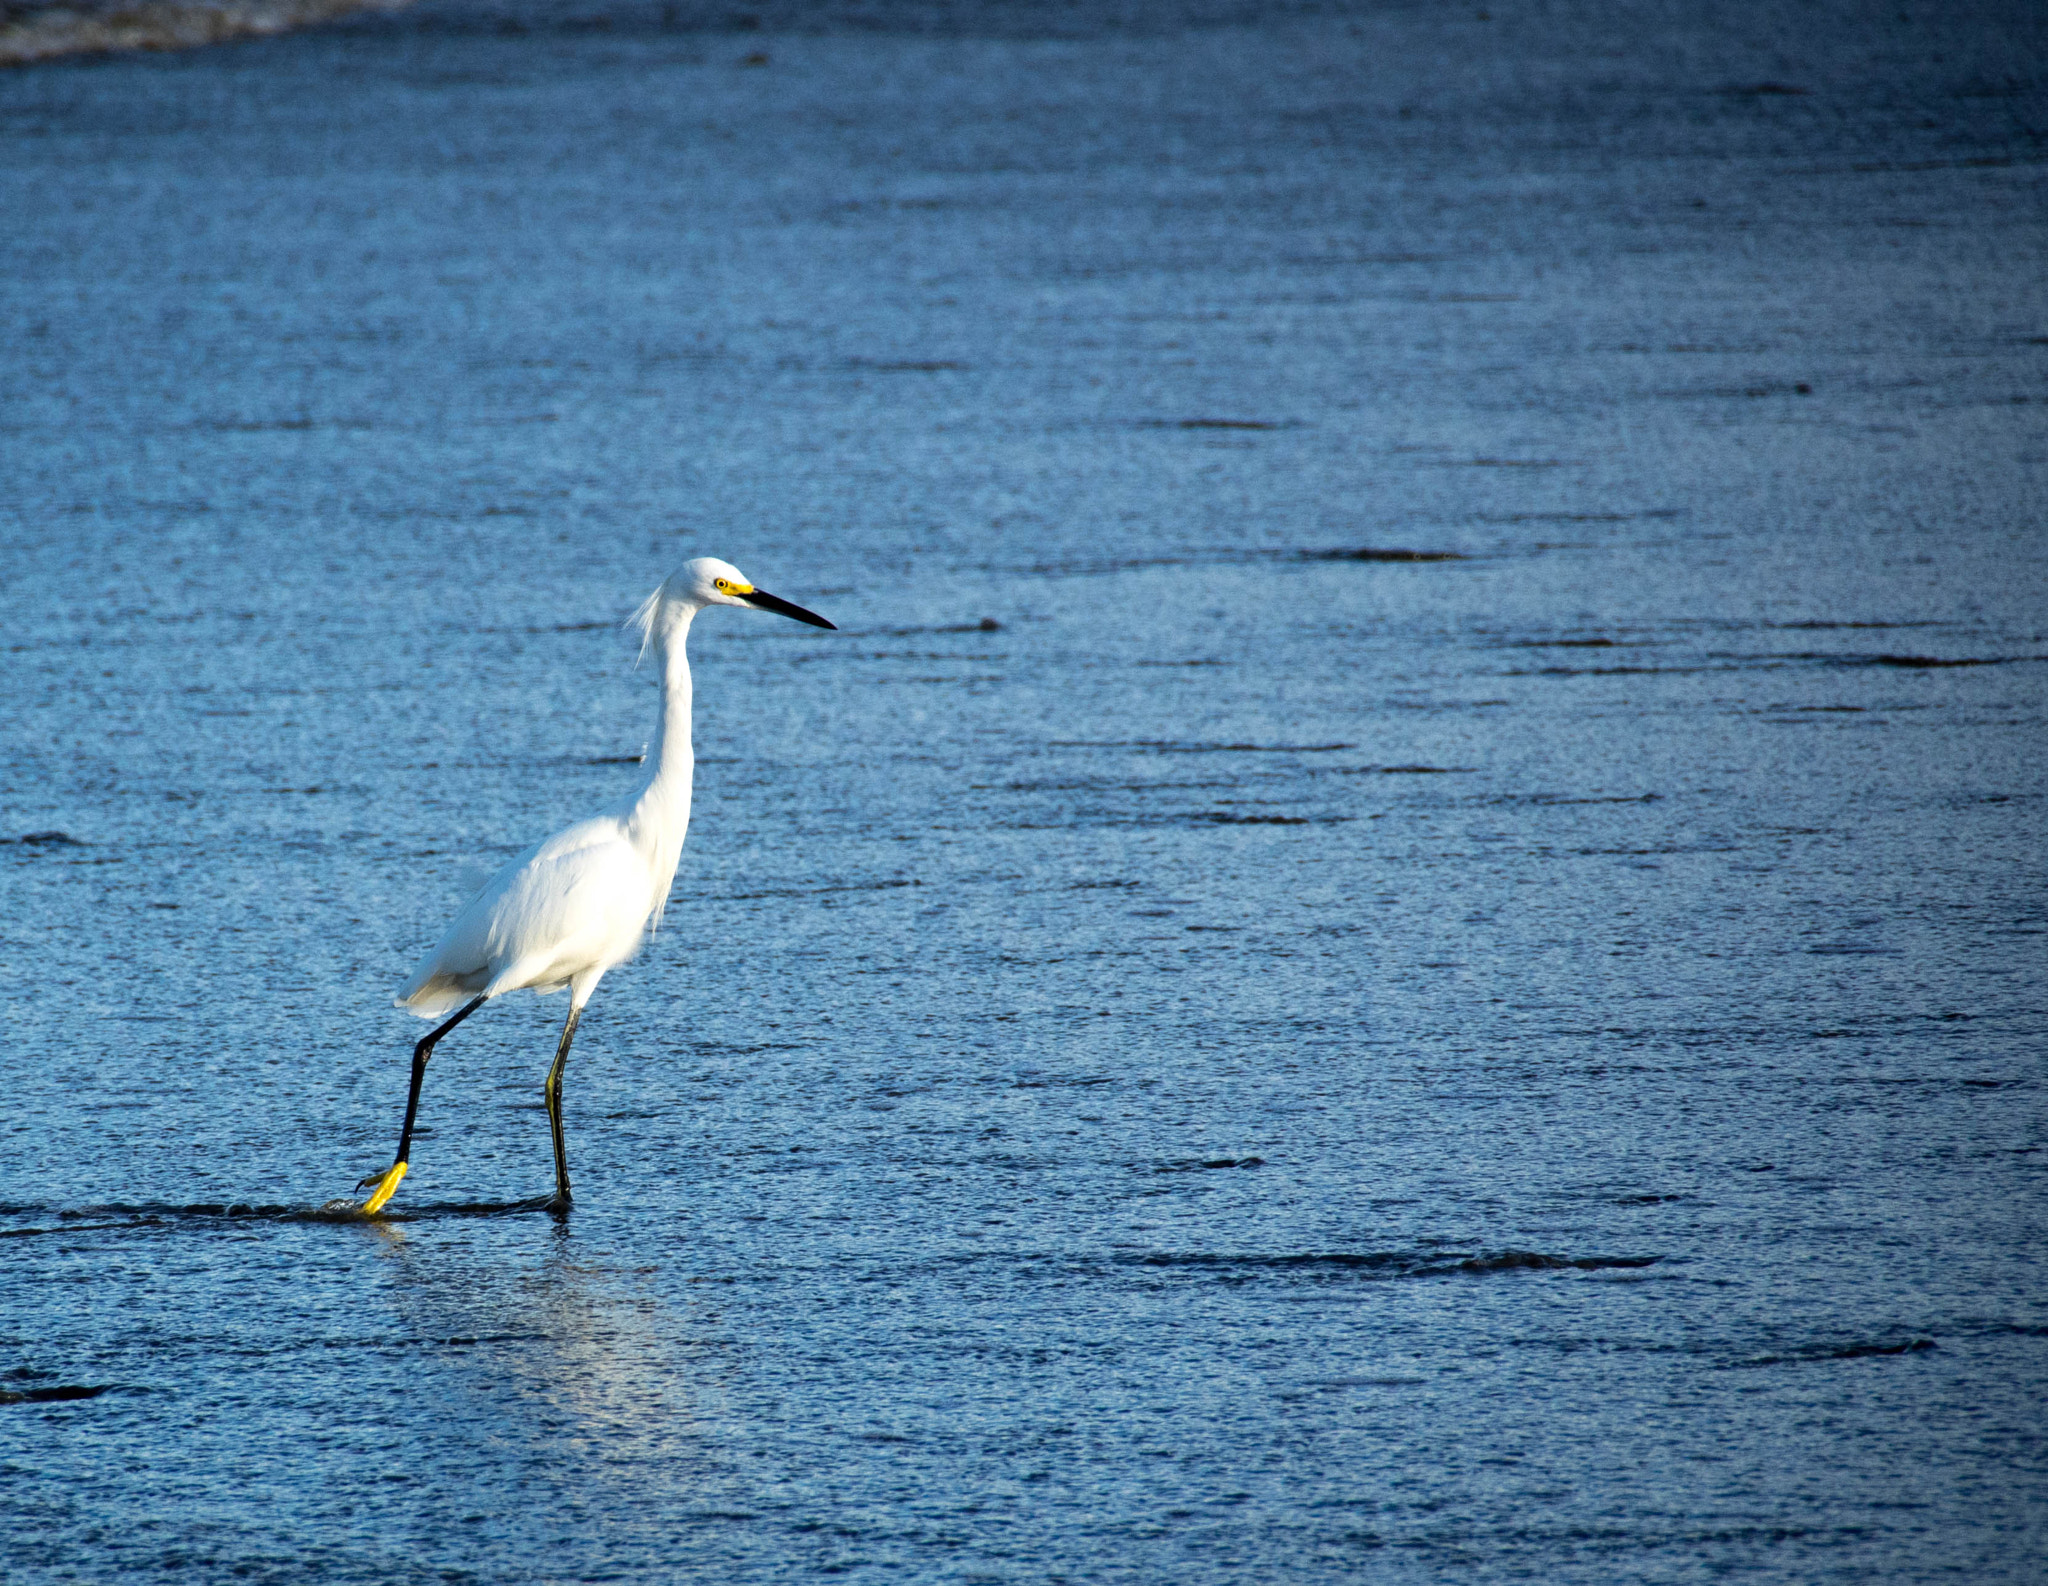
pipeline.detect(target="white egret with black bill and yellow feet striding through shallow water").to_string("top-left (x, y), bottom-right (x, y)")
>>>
top-left (356, 555), bottom-right (831, 1213)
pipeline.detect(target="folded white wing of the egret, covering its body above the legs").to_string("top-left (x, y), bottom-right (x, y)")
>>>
top-left (397, 816), bottom-right (653, 1014)
